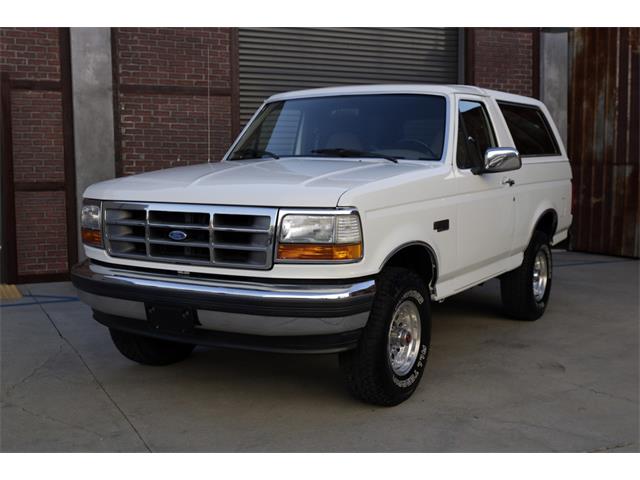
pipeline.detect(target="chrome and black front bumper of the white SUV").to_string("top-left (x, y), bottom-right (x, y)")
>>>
top-left (71, 261), bottom-right (375, 352)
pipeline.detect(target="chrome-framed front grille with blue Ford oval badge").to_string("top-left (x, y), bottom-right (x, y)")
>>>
top-left (102, 202), bottom-right (277, 269)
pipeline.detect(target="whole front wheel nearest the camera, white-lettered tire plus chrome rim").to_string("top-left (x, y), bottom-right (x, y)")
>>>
top-left (340, 267), bottom-right (431, 406)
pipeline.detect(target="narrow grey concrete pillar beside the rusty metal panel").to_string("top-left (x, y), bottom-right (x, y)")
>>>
top-left (540, 28), bottom-right (569, 145)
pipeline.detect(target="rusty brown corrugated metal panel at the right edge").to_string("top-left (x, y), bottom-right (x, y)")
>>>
top-left (568, 28), bottom-right (640, 258)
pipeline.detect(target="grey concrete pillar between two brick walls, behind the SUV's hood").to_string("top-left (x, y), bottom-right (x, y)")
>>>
top-left (71, 28), bottom-right (116, 259)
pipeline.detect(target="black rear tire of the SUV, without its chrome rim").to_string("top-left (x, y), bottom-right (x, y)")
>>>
top-left (500, 231), bottom-right (553, 321)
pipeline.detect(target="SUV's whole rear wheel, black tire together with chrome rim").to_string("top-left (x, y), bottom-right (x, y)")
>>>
top-left (500, 231), bottom-right (553, 320)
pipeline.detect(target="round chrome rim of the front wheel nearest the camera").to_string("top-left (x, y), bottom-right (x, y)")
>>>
top-left (387, 300), bottom-right (422, 377)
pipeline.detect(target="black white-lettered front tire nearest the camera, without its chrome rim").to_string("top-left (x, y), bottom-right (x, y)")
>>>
top-left (340, 267), bottom-right (431, 406)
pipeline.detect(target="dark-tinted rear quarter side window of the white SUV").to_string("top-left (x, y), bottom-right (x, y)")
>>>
top-left (498, 102), bottom-right (560, 157)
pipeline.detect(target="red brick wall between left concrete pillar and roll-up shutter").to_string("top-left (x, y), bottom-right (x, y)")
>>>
top-left (114, 28), bottom-right (232, 175)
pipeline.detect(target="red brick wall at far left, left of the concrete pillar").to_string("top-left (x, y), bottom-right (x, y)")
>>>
top-left (0, 28), bottom-right (70, 280)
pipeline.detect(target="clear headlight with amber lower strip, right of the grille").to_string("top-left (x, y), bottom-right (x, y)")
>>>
top-left (277, 211), bottom-right (363, 261)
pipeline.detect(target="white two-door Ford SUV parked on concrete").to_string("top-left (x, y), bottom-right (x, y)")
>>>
top-left (72, 85), bottom-right (571, 405)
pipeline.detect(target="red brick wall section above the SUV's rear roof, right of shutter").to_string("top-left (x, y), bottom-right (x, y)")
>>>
top-left (467, 28), bottom-right (539, 97)
